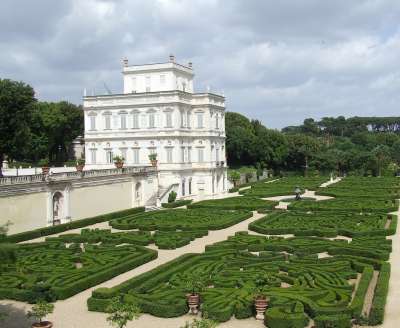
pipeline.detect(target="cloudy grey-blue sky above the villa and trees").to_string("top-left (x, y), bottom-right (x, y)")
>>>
top-left (0, 0), bottom-right (400, 128)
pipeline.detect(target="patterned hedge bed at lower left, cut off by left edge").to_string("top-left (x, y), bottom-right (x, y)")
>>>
top-left (0, 240), bottom-right (157, 302)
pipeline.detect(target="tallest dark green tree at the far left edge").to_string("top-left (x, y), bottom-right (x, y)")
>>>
top-left (0, 79), bottom-right (36, 177)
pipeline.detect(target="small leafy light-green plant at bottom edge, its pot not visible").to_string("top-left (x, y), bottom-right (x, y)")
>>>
top-left (107, 296), bottom-right (140, 328)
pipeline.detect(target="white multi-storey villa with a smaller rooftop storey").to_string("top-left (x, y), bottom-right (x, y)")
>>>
top-left (83, 56), bottom-right (228, 202)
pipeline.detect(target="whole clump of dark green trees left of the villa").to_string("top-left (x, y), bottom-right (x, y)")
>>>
top-left (0, 79), bottom-right (83, 167)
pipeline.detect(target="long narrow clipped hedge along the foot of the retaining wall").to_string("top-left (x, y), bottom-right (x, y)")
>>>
top-left (4, 207), bottom-right (145, 243)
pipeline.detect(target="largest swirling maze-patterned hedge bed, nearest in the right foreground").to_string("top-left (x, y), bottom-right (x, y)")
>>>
top-left (88, 233), bottom-right (391, 327)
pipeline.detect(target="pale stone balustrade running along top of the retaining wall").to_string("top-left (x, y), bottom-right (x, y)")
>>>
top-left (0, 166), bottom-right (157, 186)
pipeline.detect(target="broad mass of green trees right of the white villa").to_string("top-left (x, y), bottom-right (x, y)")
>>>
top-left (226, 112), bottom-right (400, 175)
